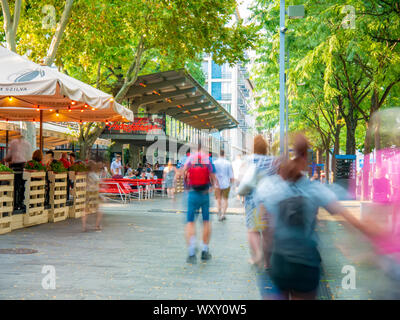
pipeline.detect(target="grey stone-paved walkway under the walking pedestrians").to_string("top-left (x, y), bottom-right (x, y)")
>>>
top-left (0, 195), bottom-right (394, 300)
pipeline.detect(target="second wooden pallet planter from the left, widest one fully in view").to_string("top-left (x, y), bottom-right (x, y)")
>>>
top-left (23, 170), bottom-right (49, 227)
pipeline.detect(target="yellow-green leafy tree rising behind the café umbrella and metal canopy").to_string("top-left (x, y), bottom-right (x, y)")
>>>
top-left (57, 0), bottom-right (255, 158)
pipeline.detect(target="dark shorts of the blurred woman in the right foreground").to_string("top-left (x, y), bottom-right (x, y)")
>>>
top-left (270, 254), bottom-right (320, 292)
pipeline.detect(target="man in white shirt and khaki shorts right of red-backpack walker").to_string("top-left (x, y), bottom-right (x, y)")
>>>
top-left (214, 150), bottom-right (234, 221)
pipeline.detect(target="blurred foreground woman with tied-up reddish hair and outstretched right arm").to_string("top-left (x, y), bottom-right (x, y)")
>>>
top-left (256, 135), bottom-right (379, 300)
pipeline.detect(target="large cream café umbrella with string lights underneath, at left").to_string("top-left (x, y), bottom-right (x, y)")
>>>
top-left (0, 46), bottom-right (133, 122)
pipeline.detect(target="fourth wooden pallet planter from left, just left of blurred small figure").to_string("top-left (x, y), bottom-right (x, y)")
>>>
top-left (68, 171), bottom-right (87, 218)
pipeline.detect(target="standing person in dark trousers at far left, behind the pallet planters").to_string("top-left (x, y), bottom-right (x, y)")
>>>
top-left (4, 135), bottom-right (32, 210)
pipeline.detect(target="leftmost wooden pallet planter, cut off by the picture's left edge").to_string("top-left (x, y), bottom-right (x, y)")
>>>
top-left (0, 172), bottom-right (14, 234)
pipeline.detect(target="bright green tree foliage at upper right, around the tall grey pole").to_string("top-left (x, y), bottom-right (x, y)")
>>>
top-left (252, 0), bottom-right (400, 153)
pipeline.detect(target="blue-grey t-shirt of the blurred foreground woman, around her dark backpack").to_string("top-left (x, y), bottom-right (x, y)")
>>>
top-left (255, 175), bottom-right (337, 266)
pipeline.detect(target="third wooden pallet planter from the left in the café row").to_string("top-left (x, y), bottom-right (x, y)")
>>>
top-left (48, 171), bottom-right (69, 222)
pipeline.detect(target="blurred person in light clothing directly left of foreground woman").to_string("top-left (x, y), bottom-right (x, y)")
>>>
top-left (242, 135), bottom-right (276, 268)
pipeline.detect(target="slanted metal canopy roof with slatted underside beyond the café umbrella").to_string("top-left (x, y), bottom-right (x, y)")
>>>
top-left (127, 69), bottom-right (239, 130)
